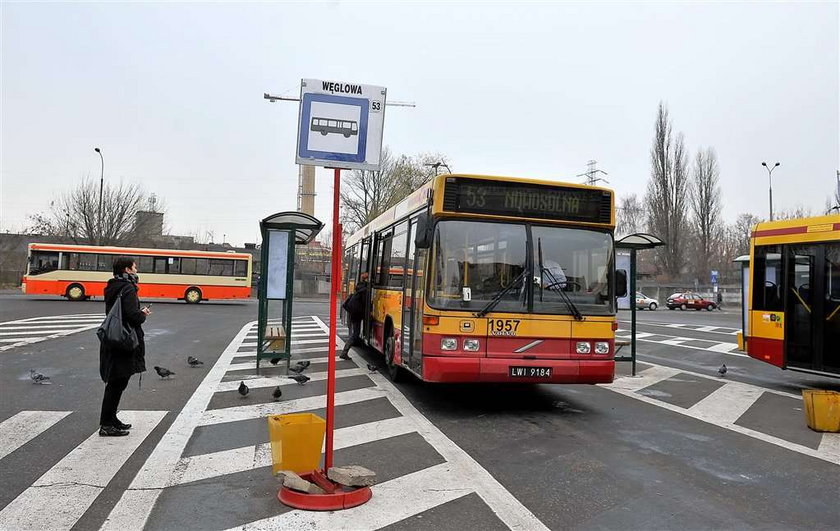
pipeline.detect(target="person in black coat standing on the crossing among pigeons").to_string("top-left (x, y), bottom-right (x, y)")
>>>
top-left (99, 256), bottom-right (152, 437)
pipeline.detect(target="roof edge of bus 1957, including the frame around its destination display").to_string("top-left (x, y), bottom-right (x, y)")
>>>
top-left (345, 173), bottom-right (614, 248)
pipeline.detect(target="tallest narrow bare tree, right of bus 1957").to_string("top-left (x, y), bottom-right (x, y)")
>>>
top-left (645, 102), bottom-right (689, 278)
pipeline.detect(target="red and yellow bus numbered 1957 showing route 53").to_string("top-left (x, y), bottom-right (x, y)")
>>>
top-left (342, 175), bottom-right (627, 384)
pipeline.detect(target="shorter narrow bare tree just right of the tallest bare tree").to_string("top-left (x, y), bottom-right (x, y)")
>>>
top-left (690, 147), bottom-right (721, 278)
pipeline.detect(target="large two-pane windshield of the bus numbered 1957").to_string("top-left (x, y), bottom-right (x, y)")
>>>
top-left (428, 220), bottom-right (614, 315)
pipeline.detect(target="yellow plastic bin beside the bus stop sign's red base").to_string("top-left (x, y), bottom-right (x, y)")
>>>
top-left (268, 413), bottom-right (327, 474)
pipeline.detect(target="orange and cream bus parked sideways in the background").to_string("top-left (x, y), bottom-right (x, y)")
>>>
top-left (21, 243), bottom-right (251, 304)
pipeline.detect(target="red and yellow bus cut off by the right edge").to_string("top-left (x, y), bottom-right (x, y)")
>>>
top-left (747, 215), bottom-right (840, 376)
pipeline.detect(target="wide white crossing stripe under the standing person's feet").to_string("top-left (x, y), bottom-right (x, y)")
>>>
top-left (0, 411), bottom-right (166, 530)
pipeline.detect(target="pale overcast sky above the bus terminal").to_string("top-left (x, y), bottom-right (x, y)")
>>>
top-left (0, 2), bottom-right (840, 245)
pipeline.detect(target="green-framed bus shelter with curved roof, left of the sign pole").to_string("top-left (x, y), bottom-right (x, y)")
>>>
top-left (257, 212), bottom-right (324, 374)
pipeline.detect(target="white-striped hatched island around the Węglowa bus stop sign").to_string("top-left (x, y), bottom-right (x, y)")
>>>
top-left (98, 316), bottom-right (546, 531)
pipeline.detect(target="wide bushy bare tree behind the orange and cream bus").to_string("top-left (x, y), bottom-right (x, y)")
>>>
top-left (28, 180), bottom-right (162, 245)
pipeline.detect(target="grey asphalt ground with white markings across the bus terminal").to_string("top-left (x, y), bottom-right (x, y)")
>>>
top-left (0, 293), bottom-right (840, 529)
